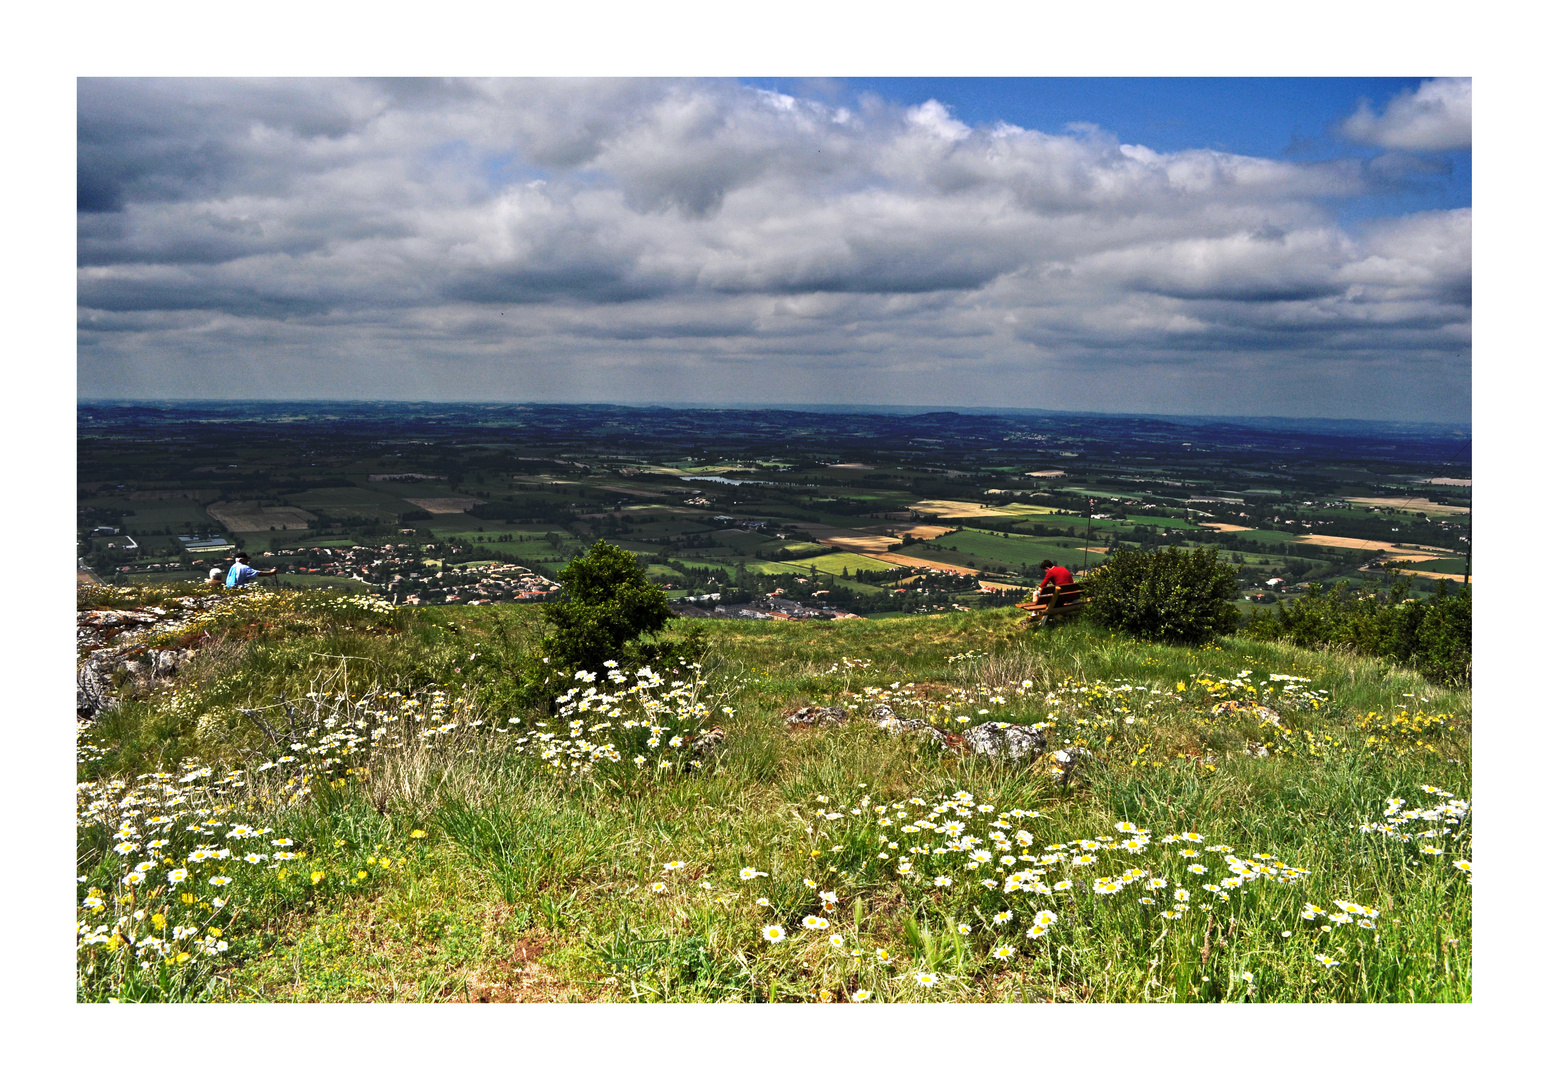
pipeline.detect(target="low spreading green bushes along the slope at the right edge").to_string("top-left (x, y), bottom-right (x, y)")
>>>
top-left (1244, 576), bottom-right (1473, 686)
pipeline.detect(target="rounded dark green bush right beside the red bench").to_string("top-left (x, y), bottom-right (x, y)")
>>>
top-left (1086, 547), bottom-right (1238, 645)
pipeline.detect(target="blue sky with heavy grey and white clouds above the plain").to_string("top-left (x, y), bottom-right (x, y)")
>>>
top-left (77, 77), bottom-right (1472, 421)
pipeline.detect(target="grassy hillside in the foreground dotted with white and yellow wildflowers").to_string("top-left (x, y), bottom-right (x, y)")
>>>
top-left (77, 590), bottom-right (1472, 1001)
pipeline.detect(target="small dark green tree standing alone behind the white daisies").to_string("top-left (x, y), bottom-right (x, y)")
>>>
top-left (542, 541), bottom-right (672, 671)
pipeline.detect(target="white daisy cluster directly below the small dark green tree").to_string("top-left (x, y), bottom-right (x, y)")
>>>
top-left (497, 660), bottom-right (733, 776)
